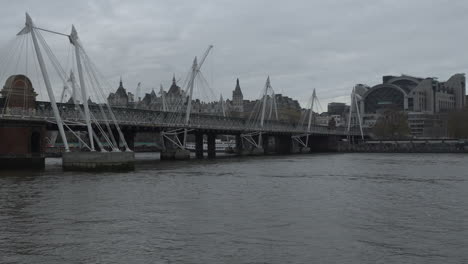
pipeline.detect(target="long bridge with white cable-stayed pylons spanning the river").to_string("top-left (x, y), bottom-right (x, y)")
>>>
top-left (0, 14), bottom-right (364, 169)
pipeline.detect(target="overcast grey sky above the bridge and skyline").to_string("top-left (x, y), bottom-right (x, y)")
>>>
top-left (0, 0), bottom-right (468, 108)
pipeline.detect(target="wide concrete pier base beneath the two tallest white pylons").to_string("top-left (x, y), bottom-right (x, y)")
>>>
top-left (62, 151), bottom-right (135, 171)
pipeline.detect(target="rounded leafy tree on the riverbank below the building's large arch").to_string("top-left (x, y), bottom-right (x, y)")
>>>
top-left (372, 109), bottom-right (411, 139)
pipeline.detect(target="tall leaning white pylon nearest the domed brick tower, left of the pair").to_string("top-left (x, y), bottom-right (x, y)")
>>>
top-left (20, 13), bottom-right (70, 152)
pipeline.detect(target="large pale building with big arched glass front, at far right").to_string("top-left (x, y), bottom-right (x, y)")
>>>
top-left (358, 74), bottom-right (466, 137)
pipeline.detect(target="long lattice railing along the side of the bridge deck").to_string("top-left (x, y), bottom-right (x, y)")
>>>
top-left (0, 104), bottom-right (366, 135)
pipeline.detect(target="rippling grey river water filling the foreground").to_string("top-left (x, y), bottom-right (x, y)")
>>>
top-left (0, 154), bottom-right (468, 263)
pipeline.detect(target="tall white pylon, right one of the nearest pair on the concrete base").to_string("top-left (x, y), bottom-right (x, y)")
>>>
top-left (70, 26), bottom-right (96, 151)
